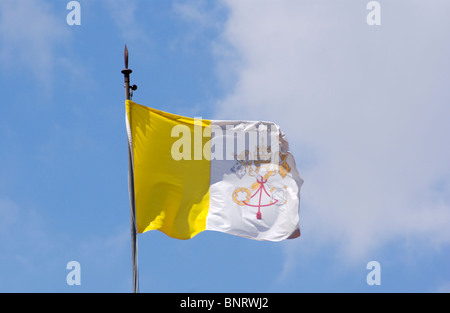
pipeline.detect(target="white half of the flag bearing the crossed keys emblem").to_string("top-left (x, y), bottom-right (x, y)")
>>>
top-left (206, 121), bottom-right (303, 241)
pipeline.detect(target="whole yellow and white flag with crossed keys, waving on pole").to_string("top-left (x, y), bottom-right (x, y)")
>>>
top-left (126, 100), bottom-right (303, 241)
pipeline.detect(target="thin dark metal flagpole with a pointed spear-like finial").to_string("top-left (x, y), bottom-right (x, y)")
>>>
top-left (122, 45), bottom-right (139, 293)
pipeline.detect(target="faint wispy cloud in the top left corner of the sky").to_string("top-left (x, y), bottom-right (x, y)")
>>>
top-left (0, 0), bottom-right (70, 86)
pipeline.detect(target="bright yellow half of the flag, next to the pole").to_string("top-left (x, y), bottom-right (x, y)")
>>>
top-left (126, 100), bottom-right (211, 239)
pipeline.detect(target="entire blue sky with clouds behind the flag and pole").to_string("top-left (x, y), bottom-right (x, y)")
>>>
top-left (0, 0), bottom-right (450, 293)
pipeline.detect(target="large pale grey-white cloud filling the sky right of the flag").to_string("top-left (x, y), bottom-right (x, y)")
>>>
top-left (217, 0), bottom-right (450, 259)
